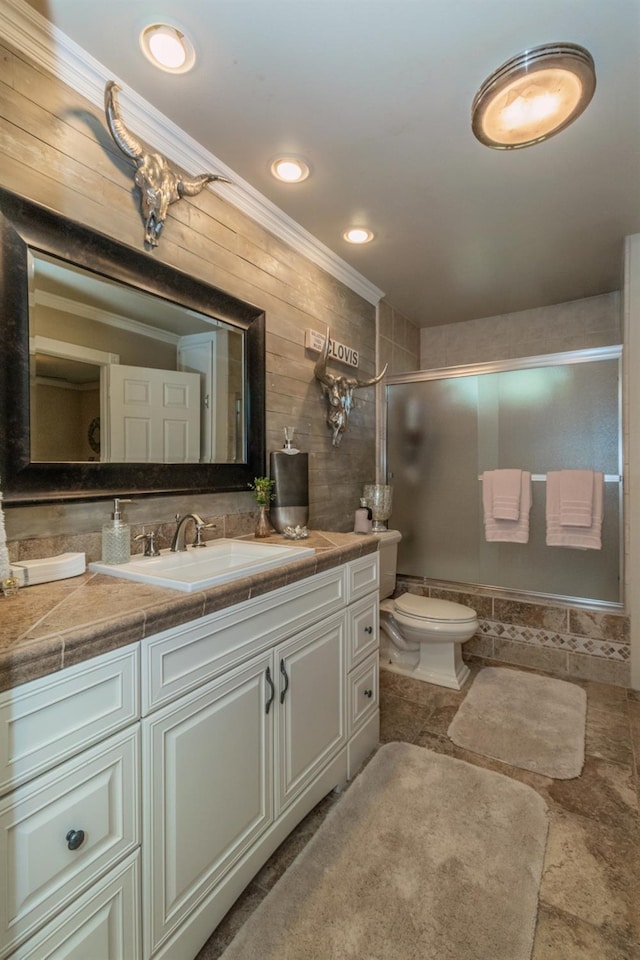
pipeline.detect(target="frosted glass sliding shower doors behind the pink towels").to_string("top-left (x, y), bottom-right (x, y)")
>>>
top-left (386, 347), bottom-right (622, 604)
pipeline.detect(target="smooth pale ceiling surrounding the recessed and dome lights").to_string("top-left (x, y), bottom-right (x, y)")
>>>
top-left (20, 0), bottom-right (640, 326)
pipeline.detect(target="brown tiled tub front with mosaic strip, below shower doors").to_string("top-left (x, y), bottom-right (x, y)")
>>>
top-left (395, 576), bottom-right (631, 687)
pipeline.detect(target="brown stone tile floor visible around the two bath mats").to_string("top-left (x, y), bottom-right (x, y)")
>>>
top-left (196, 661), bottom-right (640, 960)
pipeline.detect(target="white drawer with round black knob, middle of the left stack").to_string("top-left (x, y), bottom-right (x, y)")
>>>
top-left (0, 724), bottom-right (140, 957)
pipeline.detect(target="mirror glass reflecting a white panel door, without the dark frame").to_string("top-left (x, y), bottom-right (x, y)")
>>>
top-left (29, 250), bottom-right (246, 464)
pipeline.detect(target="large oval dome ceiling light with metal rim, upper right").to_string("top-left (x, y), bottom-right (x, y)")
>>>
top-left (471, 43), bottom-right (596, 150)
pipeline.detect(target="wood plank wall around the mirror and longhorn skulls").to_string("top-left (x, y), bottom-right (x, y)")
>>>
top-left (0, 37), bottom-right (384, 532)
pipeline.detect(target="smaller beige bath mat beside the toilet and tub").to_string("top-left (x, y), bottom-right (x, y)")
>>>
top-left (448, 667), bottom-right (587, 780)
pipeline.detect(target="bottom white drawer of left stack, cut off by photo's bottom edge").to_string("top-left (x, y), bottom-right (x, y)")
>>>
top-left (11, 852), bottom-right (142, 960)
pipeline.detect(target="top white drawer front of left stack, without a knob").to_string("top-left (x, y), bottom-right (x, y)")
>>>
top-left (0, 644), bottom-right (140, 796)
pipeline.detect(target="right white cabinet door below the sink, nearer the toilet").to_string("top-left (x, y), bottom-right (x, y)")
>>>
top-left (275, 611), bottom-right (346, 813)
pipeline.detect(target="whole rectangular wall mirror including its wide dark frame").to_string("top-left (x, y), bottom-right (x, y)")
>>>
top-left (0, 183), bottom-right (265, 504)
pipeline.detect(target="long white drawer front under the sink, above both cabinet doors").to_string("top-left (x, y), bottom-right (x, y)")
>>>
top-left (141, 567), bottom-right (345, 716)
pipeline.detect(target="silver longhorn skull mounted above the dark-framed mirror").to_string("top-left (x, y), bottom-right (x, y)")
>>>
top-left (104, 80), bottom-right (231, 247)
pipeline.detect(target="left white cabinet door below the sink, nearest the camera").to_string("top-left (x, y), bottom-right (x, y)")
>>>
top-left (142, 652), bottom-right (273, 956)
